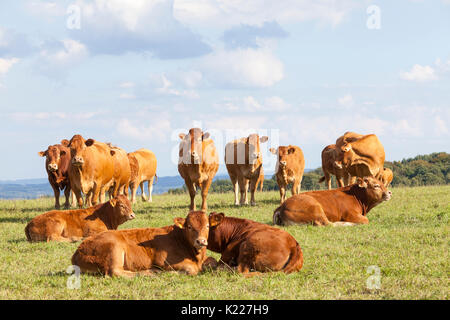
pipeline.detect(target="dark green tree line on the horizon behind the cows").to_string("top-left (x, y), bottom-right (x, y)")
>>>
top-left (168, 152), bottom-right (450, 194)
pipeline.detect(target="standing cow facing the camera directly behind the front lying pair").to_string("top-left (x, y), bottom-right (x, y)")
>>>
top-left (178, 128), bottom-right (219, 212)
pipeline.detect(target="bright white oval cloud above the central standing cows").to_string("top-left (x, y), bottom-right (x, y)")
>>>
top-left (199, 48), bottom-right (284, 88)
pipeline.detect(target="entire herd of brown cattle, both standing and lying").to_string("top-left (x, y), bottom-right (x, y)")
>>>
top-left (25, 128), bottom-right (393, 276)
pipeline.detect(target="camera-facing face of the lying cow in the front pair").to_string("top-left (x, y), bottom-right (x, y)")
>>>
top-left (174, 211), bottom-right (209, 250)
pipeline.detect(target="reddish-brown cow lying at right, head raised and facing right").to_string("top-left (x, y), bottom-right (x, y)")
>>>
top-left (273, 177), bottom-right (392, 226)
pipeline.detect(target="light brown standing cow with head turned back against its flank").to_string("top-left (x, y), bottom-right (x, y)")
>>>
top-left (336, 133), bottom-right (385, 179)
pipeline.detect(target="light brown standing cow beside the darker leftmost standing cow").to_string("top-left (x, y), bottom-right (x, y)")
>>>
top-left (68, 135), bottom-right (115, 208)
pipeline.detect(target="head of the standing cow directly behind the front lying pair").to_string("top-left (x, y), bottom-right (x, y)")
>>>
top-left (178, 128), bottom-right (210, 164)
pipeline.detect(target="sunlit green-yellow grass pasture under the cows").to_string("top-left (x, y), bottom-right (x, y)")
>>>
top-left (0, 186), bottom-right (450, 299)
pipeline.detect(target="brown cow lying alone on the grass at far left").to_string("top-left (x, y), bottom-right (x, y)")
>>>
top-left (25, 195), bottom-right (135, 242)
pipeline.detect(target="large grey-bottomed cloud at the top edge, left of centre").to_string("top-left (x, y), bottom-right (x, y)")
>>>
top-left (71, 0), bottom-right (210, 59)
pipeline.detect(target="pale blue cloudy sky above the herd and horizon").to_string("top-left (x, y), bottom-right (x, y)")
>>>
top-left (0, 0), bottom-right (450, 180)
